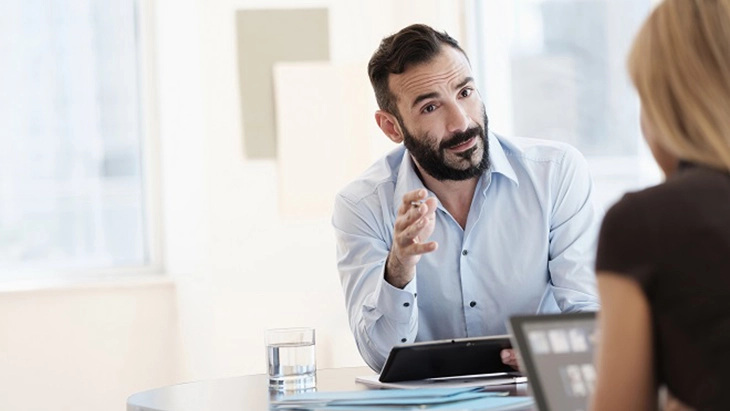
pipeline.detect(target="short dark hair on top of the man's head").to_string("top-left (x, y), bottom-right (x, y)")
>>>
top-left (368, 24), bottom-right (466, 119)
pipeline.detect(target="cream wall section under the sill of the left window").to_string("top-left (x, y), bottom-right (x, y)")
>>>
top-left (0, 282), bottom-right (179, 410)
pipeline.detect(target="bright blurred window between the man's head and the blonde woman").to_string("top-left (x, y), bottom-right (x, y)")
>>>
top-left (467, 0), bottom-right (660, 207)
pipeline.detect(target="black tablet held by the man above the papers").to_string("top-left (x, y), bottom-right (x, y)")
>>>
top-left (380, 335), bottom-right (515, 382)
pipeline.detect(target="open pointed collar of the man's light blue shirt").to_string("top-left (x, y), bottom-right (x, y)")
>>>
top-left (393, 131), bottom-right (519, 214)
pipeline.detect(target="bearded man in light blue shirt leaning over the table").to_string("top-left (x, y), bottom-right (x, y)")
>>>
top-left (332, 25), bottom-right (601, 371)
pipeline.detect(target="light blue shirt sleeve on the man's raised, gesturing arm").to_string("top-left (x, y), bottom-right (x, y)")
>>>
top-left (332, 194), bottom-right (418, 372)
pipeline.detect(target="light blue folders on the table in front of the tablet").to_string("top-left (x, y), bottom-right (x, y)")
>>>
top-left (270, 388), bottom-right (533, 411)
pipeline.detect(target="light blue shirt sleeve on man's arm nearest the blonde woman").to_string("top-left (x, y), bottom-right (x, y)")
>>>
top-left (548, 147), bottom-right (603, 312)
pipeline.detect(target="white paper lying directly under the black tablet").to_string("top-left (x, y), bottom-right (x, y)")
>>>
top-left (355, 374), bottom-right (527, 388)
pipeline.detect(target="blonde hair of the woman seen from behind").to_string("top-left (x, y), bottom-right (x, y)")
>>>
top-left (628, 0), bottom-right (730, 171)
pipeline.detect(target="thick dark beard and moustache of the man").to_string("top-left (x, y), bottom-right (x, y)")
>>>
top-left (399, 111), bottom-right (490, 181)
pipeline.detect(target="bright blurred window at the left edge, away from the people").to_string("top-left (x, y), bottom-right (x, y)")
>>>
top-left (0, 0), bottom-right (153, 280)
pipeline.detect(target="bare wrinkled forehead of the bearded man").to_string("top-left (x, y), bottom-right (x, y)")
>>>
top-left (388, 45), bottom-right (472, 102)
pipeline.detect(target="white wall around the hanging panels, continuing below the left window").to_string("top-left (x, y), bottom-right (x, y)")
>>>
top-left (0, 0), bottom-right (465, 410)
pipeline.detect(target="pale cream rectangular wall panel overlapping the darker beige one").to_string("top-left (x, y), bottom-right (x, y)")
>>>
top-left (274, 63), bottom-right (386, 218)
